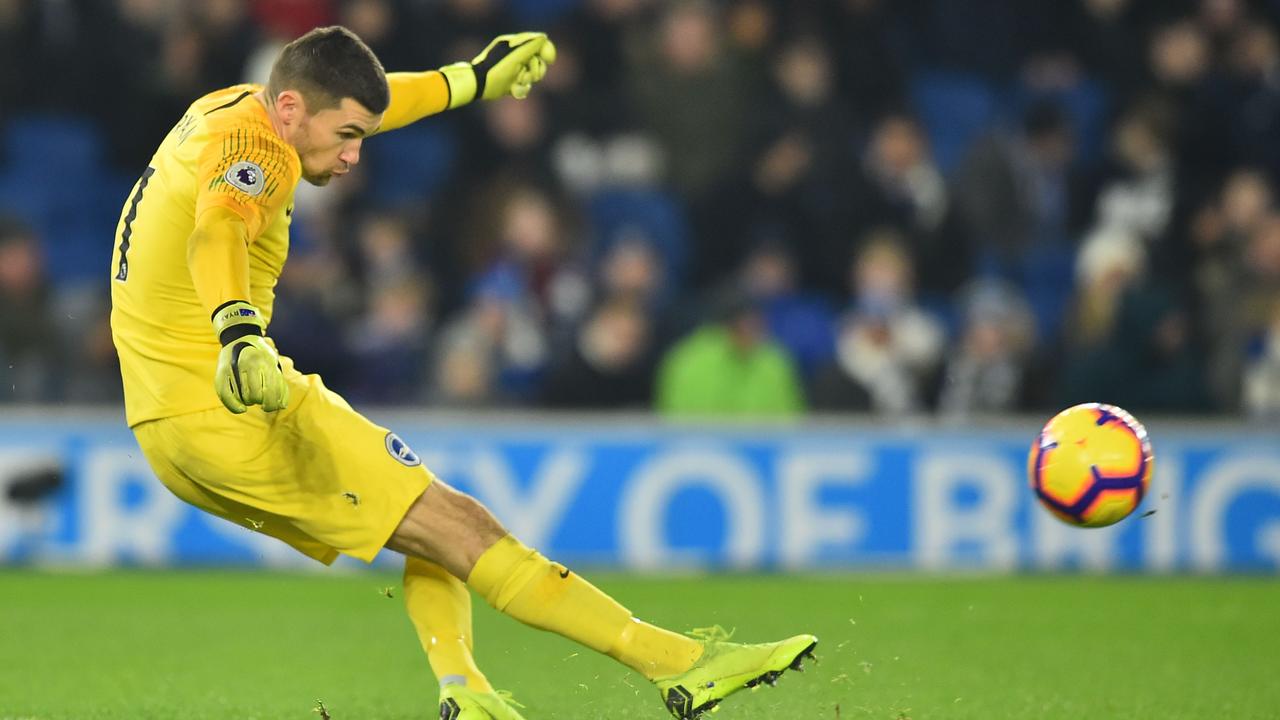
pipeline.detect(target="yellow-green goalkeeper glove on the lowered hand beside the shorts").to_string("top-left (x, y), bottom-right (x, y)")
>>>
top-left (214, 300), bottom-right (289, 415)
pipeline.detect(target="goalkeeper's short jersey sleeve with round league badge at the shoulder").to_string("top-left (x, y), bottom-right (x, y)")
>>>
top-left (196, 127), bottom-right (301, 242)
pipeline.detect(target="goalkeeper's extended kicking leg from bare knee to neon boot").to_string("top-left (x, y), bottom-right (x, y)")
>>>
top-left (387, 480), bottom-right (817, 719)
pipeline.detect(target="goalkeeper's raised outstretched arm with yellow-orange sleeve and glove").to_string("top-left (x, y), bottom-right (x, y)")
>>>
top-left (378, 32), bottom-right (556, 132)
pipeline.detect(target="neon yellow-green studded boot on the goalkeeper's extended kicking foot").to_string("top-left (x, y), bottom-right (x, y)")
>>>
top-left (654, 628), bottom-right (818, 720)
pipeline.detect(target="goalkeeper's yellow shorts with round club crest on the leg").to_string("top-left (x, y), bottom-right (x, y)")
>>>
top-left (133, 372), bottom-right (435, 565)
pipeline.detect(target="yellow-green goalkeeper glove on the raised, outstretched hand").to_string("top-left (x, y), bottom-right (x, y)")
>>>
top-left (440, 32), bottom-right (556, 110)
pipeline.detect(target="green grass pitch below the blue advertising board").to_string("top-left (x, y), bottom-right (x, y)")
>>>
top-left (0, 571), bottom-right (1280, 720)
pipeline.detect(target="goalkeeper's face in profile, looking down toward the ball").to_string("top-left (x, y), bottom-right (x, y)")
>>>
top-left (294, 97), bottom-right (383, 184)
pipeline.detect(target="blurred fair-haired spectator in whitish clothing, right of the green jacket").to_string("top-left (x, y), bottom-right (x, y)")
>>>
top-left (813, 229), bottom-right (945, 415)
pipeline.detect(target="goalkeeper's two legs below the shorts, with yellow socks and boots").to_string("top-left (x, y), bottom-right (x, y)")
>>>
top-left (387, 474), bottom-right (817, 720)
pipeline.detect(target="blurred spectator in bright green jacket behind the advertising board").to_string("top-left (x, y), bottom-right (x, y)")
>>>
top-left (657, 289), bottom-right (805, 418)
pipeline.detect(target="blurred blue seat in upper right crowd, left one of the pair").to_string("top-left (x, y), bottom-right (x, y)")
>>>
top-left (911, 72), bottom-right (1000, 176)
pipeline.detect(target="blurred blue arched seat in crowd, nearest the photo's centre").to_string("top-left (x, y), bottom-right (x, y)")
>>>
top-left (586, 190), bottom-right (689, 282)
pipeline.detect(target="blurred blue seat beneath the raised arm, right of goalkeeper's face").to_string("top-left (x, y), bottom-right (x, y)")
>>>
top-left (364, 122), bottom-right (457, 205)
